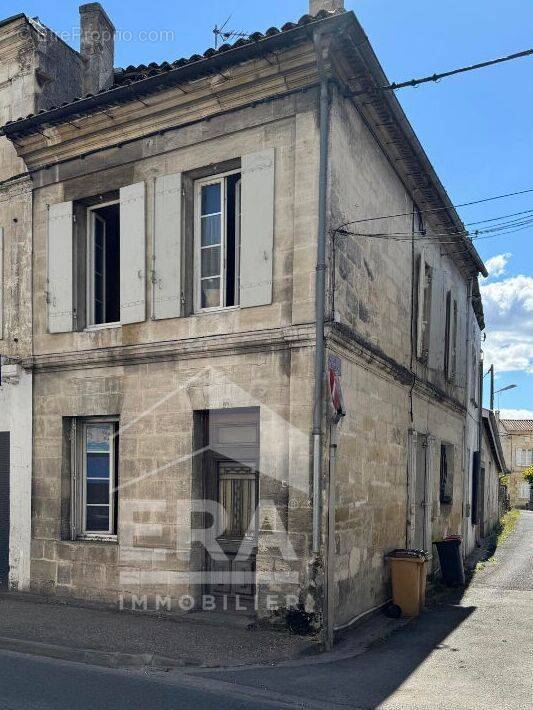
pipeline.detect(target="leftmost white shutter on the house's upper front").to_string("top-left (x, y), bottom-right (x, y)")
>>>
top-left (47, 202), bottom-right (74, 333)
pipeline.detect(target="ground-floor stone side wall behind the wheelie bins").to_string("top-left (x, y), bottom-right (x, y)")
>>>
top-left (328, 352), bottom-right (464, 625)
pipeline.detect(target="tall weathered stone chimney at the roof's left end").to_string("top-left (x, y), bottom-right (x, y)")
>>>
top-left (80, 2), bottom-right (115, 96)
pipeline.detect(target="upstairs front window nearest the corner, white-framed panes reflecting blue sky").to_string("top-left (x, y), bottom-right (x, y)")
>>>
top-left (195, 173), bottom-right (241, 311)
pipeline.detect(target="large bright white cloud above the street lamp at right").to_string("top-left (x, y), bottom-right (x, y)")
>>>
top-left (481, 275), bottom-right (533, 374)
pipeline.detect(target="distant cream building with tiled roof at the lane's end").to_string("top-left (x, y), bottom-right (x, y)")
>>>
top-left (500, 419), bottom-right (533, 508)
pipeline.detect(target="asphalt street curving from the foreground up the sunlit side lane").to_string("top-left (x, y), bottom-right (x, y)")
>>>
top-left (0, 512), bottom-right (533, 710)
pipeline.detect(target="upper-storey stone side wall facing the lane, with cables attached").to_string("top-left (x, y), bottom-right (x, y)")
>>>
top-left (329, 87), bottom-right (471, 404)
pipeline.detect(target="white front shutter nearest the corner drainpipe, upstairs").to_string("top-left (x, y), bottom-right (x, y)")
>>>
top-left (240, 148), bottom-right (275, 308)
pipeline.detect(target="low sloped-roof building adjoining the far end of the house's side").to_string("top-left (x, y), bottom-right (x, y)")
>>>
top-left (478, 409), bottom-right (508, 539)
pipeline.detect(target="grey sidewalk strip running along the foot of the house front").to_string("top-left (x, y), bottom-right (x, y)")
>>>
top-left (0, 592), bottom-right (320, 668)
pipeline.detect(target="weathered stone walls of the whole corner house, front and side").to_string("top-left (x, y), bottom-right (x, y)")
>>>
top-left (6, 3), bottom-right (483, 627)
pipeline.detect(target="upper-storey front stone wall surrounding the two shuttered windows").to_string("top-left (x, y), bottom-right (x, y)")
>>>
top-left (34, 92), bottom-right (318, 356)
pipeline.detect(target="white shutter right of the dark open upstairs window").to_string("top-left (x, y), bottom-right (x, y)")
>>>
top-left (120, 182), bottom-right (146, 325)
